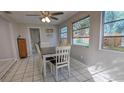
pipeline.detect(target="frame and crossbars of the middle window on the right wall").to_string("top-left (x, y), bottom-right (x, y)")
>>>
top-left (72, 15), bottom-right (90, 48)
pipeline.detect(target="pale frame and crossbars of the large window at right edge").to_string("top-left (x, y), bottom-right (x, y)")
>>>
top-left (100, 11), bottom-right (124, 53)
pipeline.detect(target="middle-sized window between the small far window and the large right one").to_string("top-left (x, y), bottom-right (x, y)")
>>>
top-left (73, 16), bottom-right (90, 47)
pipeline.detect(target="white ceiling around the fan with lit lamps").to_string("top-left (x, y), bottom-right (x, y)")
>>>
top-left (5, 11), bottom-right (78, 25)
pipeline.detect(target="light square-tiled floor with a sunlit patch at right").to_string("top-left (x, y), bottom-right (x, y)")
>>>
top-left (1, 56), bottom-right (124, 82)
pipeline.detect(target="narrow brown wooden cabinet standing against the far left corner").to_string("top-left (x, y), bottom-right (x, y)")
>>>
top-left (17, 38), bottom-right (27, 58)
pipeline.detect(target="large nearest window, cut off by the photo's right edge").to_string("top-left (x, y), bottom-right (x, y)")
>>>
top-left (102, 11), bottom-right (124, 52)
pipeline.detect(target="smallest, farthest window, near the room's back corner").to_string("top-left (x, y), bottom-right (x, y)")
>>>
top-left (60, 26), bottom-right (67, 44)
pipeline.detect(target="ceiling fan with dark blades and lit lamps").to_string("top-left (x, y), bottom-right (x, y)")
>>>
top-left (26, 11), bottom-right (64, 23)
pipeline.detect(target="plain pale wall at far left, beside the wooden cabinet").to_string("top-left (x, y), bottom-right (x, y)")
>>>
top-left (0, 16), bottom-right (17, 60)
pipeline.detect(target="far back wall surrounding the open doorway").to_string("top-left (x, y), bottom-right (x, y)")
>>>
top-left (17, 24), bottom-right (57, 56)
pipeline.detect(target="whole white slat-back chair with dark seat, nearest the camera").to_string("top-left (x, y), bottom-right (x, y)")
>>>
top-left (50, 46), bottom-right (71, 81)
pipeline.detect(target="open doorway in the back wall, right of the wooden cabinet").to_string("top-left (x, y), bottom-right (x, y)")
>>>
top-left (29, 28), bottom-right (40, 54)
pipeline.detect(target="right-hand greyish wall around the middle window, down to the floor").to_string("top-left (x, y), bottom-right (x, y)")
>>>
top-left (60, 11), bottom-right (124, 66)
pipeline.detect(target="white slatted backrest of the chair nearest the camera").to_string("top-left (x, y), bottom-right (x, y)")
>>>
top-left (56, 46), bottom-right (71, 64)
